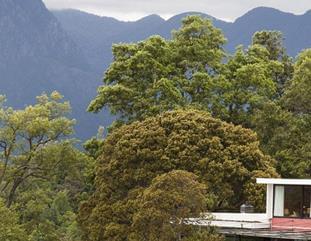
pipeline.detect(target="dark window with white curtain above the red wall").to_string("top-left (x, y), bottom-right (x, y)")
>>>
top-left (273, 185), bottom-right (311, 218)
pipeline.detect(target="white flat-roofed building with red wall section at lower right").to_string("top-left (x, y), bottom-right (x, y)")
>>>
top-left (193, 178), bottom-right (311, 240)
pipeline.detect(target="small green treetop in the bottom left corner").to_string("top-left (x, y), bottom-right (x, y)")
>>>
top-left (0, 200), bottom-right (28, 241)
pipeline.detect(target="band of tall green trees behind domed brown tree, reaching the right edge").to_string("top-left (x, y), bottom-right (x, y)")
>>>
top-left (89, 16), bottom-right (311, 177)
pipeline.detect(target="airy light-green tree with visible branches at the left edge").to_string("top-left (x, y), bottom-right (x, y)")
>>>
top-left (0, 92), bottom-right (92, 241)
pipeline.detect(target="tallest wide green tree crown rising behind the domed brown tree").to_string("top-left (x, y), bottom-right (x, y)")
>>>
top-left (89, 16), bottom-right (292, 130)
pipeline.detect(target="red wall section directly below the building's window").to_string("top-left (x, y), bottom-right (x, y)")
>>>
top-left (272, 218), bottom-right (311, 231)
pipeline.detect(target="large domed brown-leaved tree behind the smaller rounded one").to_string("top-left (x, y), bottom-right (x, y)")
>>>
top-left (78, 110), bottom-right (277, 241)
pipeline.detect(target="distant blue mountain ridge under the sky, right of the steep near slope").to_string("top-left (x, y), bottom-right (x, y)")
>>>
top-left (53, 7), bottom-right (311, 76)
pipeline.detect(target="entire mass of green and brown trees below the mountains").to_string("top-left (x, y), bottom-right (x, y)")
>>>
top-left (0, 16), bottom-right (311, 241)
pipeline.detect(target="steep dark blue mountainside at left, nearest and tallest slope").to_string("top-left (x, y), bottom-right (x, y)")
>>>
top-left (0, 0), bottom-right (113, 138)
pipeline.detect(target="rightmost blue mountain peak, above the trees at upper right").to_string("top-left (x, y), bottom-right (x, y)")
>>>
top-left (225, 7), bottom-right (311, 56)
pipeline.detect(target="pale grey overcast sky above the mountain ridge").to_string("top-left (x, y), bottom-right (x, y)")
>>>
top-left (43, 0), bottom-right (311, 21)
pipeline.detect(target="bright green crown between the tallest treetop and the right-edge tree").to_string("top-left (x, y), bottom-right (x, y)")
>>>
top-left (221, 45), bottom-right (282, 128)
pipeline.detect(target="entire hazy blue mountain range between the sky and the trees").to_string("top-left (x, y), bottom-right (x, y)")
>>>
top-left (0, 0), bottom-right (311, 139)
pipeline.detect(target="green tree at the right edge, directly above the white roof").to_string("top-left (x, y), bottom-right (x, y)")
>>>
top-left (253, 50), bottom-right (311, 178)
